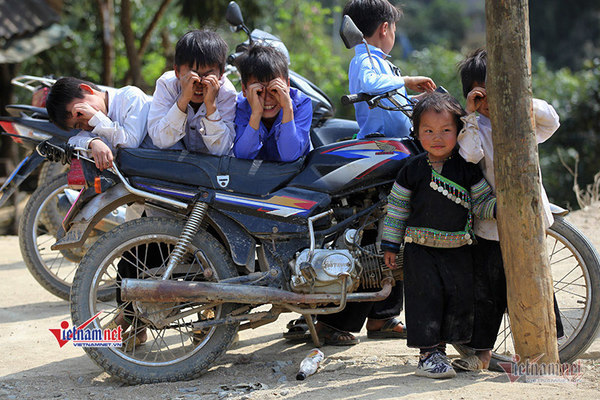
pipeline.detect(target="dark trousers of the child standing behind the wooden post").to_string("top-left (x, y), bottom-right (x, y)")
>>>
top-left (467, 237), bottom-right (564, 350)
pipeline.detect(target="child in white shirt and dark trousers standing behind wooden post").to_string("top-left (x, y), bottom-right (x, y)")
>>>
top-left (452, 49), bottom-right (564, 371)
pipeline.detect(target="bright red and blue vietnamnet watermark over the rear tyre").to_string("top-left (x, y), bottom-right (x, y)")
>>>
top-left (48, 311), bottom-right (123, 347)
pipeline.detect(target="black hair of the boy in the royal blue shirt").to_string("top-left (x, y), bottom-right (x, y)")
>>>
top-left (236, 44), bottom-right (289, 85)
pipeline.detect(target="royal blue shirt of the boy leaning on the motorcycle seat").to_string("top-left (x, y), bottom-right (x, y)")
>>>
top-left (233, 88), bottom-right (312, 161)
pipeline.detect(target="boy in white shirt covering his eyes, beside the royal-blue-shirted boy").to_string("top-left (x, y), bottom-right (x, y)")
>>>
top-left (148, 30), bottom-right (237, 155)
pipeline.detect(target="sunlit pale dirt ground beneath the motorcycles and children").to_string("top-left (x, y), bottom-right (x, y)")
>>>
top-left (0, 207), bottom-right (600, 400)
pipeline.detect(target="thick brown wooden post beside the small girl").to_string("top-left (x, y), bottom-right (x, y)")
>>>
top-left (485, 0), bottom-right (559, 363)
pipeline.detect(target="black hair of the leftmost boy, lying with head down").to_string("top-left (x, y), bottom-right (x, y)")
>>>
top-left (46, 76), bottom-right (100, 131)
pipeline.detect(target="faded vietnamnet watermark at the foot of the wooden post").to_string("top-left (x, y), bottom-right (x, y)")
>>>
top-left (498, 354), bottom-right (583, 383)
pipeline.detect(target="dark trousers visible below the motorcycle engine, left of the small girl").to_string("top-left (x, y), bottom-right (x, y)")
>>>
top-left (318, 281), bottom-right (404, 332)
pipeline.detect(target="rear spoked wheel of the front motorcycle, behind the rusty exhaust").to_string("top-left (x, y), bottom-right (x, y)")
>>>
top-left (71, 218), bottom-right (239, 384)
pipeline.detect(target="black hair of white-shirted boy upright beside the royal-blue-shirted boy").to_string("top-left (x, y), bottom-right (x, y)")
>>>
top-left (175, 29), bottom-right (229, 73)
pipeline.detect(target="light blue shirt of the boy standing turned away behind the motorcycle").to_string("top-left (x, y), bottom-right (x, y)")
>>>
top-left (348, 44), bottom-right (412, 139)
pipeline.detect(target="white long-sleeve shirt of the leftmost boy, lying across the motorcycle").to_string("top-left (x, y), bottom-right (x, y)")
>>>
top-left (69, 86), bottom-right (152, 152)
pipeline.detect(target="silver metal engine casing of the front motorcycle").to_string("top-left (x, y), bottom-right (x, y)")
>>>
top-left (290, 249), bottom-right (360, 294)
